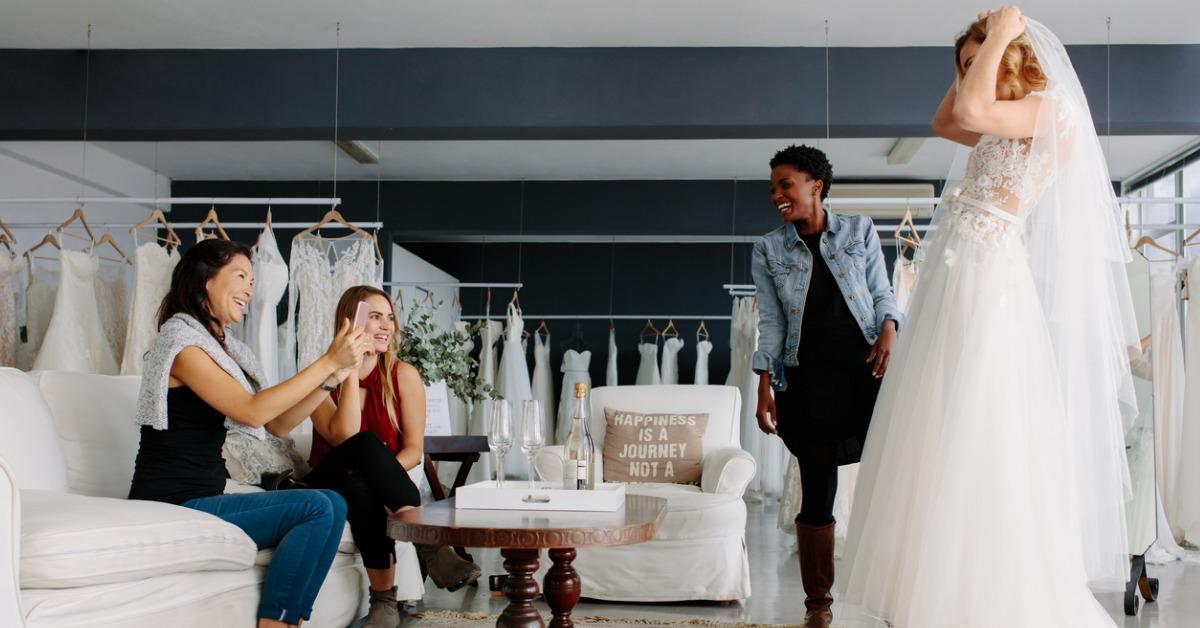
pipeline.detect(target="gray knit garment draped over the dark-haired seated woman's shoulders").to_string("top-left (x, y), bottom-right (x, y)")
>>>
top-left (136, 313), bottom-right (266, 441)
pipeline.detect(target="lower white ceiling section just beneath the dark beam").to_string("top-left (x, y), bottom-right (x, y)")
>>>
top-left (97, 136), bottom-right (1200, 180)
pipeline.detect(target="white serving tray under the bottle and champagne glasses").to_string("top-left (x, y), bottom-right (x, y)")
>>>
top-left (454, 480), bottom-right (625, 513)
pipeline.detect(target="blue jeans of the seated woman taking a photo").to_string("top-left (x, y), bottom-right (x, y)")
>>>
top-left (184, 490), bottom-right (346, 624)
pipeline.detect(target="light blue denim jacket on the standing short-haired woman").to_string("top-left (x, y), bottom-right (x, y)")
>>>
top-left (750, 210), bottom-right (904, 390)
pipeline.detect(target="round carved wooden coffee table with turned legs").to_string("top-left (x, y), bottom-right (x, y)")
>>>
top-left (388, 495), bottom-right (667, 628)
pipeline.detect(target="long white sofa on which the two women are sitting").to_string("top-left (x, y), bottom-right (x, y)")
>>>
top-left (0, 369), bottom-right (424, 628)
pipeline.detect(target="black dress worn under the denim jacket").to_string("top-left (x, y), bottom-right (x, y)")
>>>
top-left (775, 233), bottom-right (881, 465)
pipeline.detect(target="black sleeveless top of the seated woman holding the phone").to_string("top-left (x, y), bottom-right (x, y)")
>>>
top-left (130, 385), bottom-right (226, 504)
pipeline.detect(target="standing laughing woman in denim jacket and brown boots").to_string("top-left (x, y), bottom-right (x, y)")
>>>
top-left (751, 145), bottom-right (901, 628)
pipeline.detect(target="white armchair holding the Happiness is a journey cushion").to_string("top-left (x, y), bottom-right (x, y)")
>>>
top-left (535, 385), bottom-right (755, 602)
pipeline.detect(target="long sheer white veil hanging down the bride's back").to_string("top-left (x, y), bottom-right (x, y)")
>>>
top-left (922, 19), bottom-right (1139, 591)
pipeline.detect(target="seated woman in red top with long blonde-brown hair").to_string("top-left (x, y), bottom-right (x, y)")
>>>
top-left (304, 286), bottom-right (481, 628)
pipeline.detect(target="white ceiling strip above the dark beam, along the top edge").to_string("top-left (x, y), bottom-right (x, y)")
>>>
top-left (0, 0), bottom-right (1200, 48)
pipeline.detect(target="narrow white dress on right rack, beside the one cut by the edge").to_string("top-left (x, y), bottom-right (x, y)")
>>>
top-left (1150, 274), bottom-right (1195, 537)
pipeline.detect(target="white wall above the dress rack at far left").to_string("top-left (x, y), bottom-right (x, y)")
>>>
top-left (0, 142), bottom-right (170, 256)
